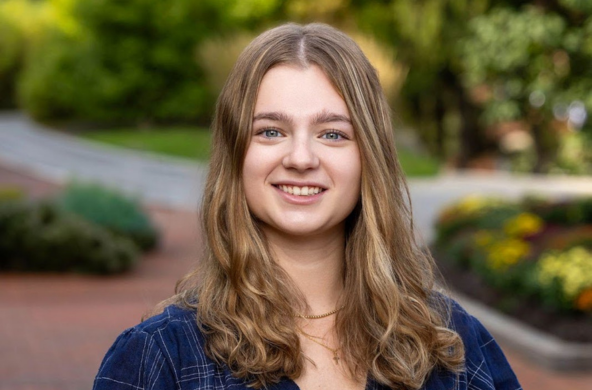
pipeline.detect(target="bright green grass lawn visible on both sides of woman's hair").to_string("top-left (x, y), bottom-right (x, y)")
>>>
top-left (82, 127), bottom-right (439, 176)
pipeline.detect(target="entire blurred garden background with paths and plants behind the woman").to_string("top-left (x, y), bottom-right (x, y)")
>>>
top-left (0, 0), bottom-right (592, 390)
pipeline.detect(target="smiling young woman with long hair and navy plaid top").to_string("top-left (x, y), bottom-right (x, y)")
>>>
top-left (95, 24), bottom-right (520, 390)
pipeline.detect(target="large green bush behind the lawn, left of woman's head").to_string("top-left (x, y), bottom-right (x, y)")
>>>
top-left (19, 0), bottom-right (227, 124)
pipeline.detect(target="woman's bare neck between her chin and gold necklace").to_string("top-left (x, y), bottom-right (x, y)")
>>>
top-left (266, 225), bottom-right (345, 314)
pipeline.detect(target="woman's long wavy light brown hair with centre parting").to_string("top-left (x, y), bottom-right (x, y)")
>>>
top-left (168, 24), bottom-right (464, 389)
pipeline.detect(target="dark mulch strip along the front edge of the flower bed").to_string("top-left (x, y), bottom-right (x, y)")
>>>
top-left (434, 253), bottom-right (592, 343)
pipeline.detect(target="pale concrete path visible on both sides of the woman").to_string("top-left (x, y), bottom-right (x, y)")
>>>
top-left (0, 112), bottom-right (592, 241)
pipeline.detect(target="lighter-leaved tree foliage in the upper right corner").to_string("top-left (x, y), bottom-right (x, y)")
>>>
top-left (458, 1), bottom-right (592, 172)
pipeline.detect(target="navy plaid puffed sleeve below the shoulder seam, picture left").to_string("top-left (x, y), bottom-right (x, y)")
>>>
top-left (93, 328), bottom-right (178, 390)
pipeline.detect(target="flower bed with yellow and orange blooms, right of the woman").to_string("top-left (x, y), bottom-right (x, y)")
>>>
top-left (433, 197), bottom-right (592, 342)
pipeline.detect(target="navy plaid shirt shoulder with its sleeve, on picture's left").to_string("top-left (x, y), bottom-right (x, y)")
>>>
top-left (94, 306), bottom-right (240, 390)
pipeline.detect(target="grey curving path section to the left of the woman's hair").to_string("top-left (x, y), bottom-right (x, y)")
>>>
top-left (0, 113), bottom-right (206, 209)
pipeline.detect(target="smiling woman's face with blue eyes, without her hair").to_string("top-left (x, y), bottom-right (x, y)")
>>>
top-left (243, 65), bottom-right (362, 236)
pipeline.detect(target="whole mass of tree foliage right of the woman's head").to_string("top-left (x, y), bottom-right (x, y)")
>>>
top-left (352, 0), bottom-right (592, 171)
